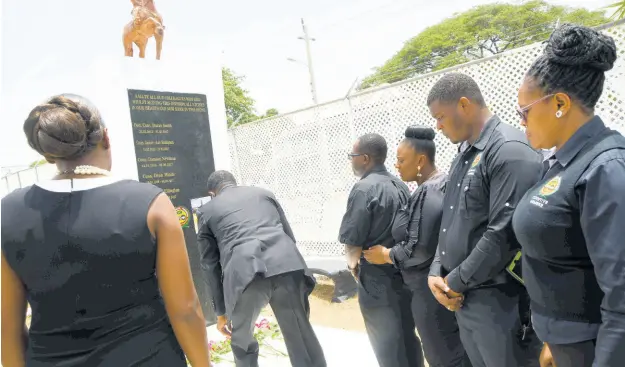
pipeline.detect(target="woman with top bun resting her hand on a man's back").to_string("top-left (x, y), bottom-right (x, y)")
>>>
top-left (364, 126), bottom-right (471, 367)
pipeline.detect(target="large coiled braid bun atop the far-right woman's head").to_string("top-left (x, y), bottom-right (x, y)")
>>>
top-left (545, 24), bottom-right (616, 71)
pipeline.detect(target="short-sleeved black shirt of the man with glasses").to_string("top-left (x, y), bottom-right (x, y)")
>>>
top-left (339, 166), bottom-right (410, 307)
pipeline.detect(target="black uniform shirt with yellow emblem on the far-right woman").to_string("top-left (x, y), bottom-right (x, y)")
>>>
top-left (513, 117), bottom-right (625, 366)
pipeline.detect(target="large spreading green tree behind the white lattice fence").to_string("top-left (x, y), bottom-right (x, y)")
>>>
top-left (358, 0), bottom-right (608, 89)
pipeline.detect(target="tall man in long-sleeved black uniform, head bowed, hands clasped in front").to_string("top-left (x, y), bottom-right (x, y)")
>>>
top-left (427, 73), bottom-right (542, 367)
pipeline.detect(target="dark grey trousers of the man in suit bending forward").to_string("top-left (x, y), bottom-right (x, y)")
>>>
top-left (231, 271), bottom-right (326, 367)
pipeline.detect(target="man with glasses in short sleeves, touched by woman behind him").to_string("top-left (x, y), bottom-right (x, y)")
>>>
top-left (339, 134), bottom-right (423, 367)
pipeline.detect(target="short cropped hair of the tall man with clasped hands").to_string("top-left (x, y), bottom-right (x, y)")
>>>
top-left (427, 73), bottom-right (486, 107)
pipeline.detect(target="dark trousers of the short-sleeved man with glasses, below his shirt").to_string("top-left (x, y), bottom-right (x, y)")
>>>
top-left (358, 277), bottom-right (423, 367)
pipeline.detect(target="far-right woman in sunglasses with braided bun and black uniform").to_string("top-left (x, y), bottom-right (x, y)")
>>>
top-left (513, 25), bottom-right (625, 367)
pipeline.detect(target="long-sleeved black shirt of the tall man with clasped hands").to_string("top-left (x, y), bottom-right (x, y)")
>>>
top-left (430, 116), bottom-right (542, 292)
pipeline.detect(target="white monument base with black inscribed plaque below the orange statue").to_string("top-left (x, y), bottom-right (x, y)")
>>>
top-left (103, 58), bottom-right (230, 325)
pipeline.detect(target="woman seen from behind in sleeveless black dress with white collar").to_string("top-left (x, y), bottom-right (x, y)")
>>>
top-left (2, 94), bottom-right (210, 367)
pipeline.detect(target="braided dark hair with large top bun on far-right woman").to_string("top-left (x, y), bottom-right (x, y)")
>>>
top-left (527, 24), bottom-right (617, 112)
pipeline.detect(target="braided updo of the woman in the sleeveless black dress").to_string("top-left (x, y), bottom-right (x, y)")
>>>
top-left (24, 94), bottom-right (104, 161)
